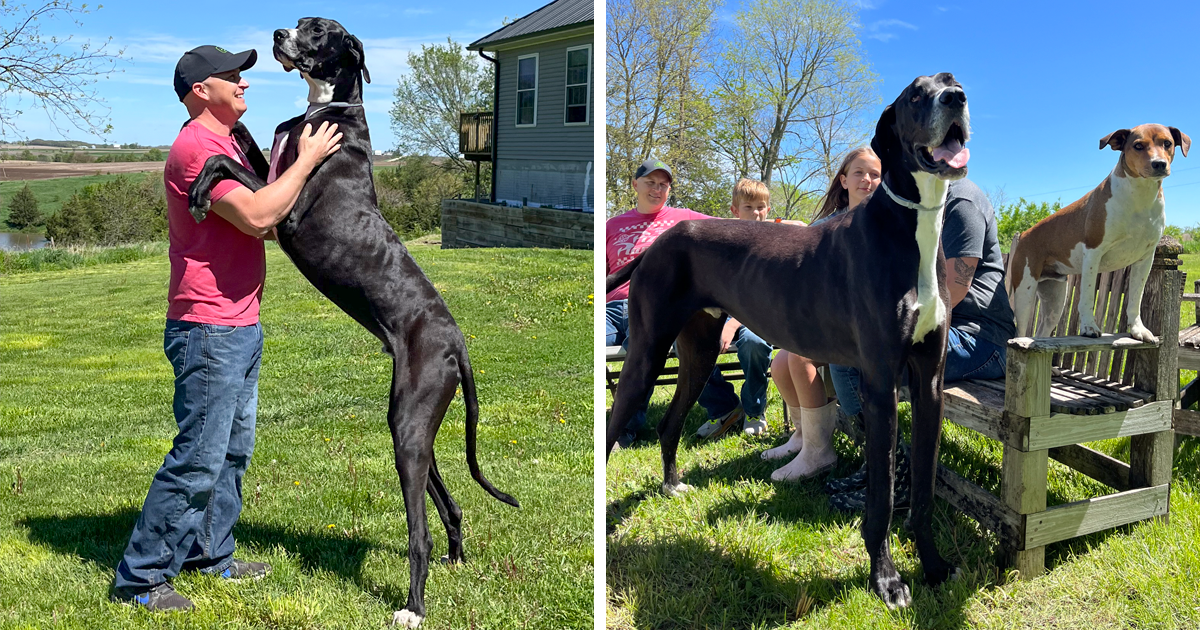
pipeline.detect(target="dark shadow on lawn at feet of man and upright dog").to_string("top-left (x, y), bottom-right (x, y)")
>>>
top-left (17, 508), bottom-right (393, 595)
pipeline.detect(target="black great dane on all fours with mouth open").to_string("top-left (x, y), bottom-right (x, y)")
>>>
top-left (607, 72), bottom-right (970, 607)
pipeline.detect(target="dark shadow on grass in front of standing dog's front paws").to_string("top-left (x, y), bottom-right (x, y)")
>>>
top-left (607, 530), bottom-right (976, 629)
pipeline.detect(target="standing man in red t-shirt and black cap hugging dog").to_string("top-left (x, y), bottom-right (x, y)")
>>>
top-left (112, 46), bottom-right (342, 611)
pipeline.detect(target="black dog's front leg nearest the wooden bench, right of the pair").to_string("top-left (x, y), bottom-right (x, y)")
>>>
top-left (907, 333), bottom-right (955, 586)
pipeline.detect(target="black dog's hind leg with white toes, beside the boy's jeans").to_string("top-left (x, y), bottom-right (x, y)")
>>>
top-left (659, 311), bottom-right (726, 496)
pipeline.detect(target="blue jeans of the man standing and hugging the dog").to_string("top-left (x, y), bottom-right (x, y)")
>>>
top-left (114, 319), bottom-right (263, 588)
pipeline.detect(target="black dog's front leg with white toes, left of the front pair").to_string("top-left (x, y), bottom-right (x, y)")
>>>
top-left (858, 362), bottom-right (912, 608)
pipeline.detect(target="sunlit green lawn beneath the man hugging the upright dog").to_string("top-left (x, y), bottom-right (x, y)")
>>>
top-left (0, 240), bottom-right (594, 629)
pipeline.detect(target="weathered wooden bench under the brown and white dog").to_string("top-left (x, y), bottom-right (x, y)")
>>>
top-left (937, 237), bottom-right (1183, 578)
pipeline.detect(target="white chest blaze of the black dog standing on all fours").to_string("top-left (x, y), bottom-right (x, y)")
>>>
top-left (912, 172), bottom-right (949, 343)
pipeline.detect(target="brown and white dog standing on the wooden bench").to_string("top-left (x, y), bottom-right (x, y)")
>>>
top-left (1007, 125), bottom-right (1192, 342)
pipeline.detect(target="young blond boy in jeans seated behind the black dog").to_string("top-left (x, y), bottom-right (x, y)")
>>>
top-left (696, 178), bottom-right (772, 438)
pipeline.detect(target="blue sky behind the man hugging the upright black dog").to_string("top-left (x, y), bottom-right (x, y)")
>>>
top-left (5, 0), bottom-right (546, 149)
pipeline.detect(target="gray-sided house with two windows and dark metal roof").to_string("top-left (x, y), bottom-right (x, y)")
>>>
top-left (467, 0), bottom-right (596, 211)
